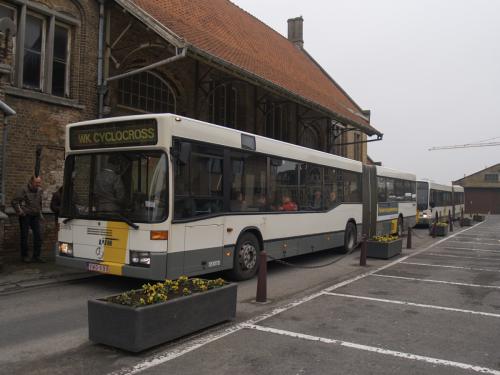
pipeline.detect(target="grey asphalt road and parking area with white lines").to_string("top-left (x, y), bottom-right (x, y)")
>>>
top-left (0, 217), bottom-right (500, 375)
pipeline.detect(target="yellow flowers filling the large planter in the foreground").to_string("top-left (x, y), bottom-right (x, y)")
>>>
top-left (107, 276), bottom-right (226, 307)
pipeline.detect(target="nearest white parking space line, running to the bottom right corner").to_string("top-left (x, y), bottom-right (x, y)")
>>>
top-left (245, 325), bottom-right (500, 375)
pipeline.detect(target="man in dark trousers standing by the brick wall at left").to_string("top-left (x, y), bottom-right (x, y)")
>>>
top-left (12, 176), bottom-right (44, 263)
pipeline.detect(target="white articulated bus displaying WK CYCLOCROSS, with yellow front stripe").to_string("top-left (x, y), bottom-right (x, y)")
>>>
top-left (56, 114), bottom-right (416, 280)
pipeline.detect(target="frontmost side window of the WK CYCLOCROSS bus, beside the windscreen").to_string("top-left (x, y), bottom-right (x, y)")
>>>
top-left (174, 142), bottom-right (224, 219)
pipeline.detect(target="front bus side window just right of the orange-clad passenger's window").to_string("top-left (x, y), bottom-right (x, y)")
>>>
top-left (299, 163), bottom-right (323, 211)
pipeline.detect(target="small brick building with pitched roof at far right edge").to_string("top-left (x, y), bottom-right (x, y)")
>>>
top-left (453, 164), bottom-right (500, 214)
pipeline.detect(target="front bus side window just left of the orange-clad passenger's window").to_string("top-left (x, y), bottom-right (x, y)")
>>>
top-left (230, 152), bottom-right (268, 212)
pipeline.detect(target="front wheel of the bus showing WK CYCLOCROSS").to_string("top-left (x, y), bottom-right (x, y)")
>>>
top-left (230, 232), bottom-right (260, 281)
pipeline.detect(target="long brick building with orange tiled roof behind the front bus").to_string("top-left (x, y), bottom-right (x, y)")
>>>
top-left (0, 0), bottom-right (382, 255)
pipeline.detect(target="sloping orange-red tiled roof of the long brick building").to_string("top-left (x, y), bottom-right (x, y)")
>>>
top-left (130, 0), bottom-right (378, 133)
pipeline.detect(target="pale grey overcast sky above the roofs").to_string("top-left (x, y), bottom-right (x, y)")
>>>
top-left (233, 0), bottom-right (500, 183)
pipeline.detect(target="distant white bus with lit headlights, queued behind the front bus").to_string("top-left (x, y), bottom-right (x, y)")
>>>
top-left (417, 181), bottom-right (464, 225)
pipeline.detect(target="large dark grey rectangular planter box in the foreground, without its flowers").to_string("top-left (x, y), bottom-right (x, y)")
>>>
top-left (88, 284), bottom-right (237, 352)
